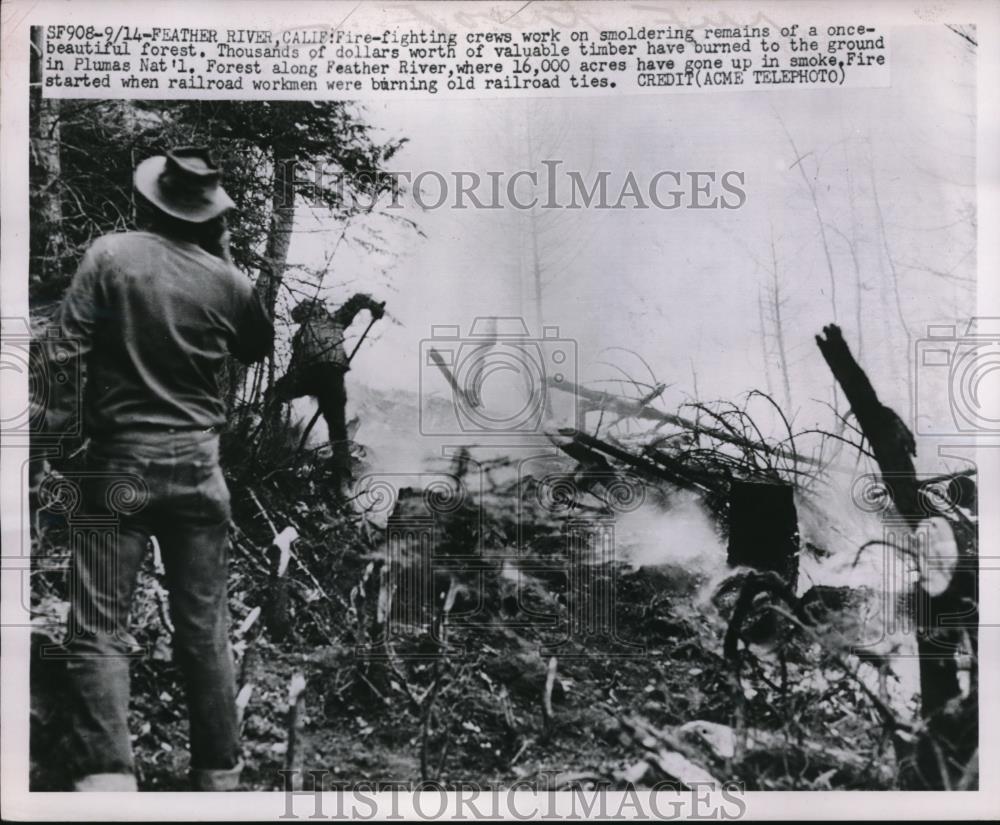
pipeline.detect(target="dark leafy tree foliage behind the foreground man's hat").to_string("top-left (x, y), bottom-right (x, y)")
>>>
top-left (31, 100), bottom-right (405, 300)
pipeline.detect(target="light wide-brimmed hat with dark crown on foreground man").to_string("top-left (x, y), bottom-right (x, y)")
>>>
top-left (135, 146), bottom-right (235, 223)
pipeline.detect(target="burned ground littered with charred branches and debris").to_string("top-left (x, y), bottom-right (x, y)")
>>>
top-left (32, 392), bottom-right (975, 790)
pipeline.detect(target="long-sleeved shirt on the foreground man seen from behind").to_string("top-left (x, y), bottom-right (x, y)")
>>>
top-left (46, 232), bottom-right (274, 437)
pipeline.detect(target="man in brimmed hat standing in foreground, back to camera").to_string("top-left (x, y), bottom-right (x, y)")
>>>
top-left (42, 148), bottom-right (274, 791)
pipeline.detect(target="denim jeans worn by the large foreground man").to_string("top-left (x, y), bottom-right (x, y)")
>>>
top-left (65, 431), bottom-right (240, 776)
